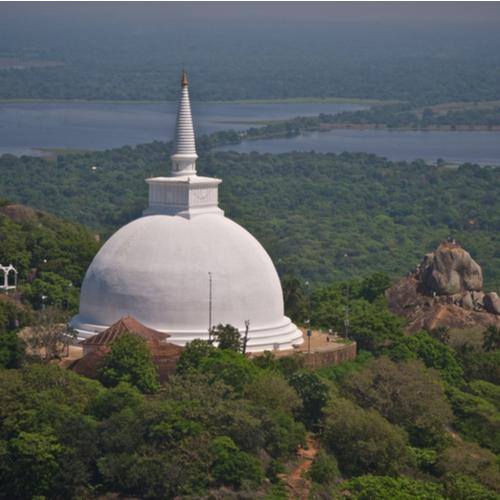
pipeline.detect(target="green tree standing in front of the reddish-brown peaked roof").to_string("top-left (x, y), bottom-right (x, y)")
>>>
top-left (98, 333), bottom-right (160, 393)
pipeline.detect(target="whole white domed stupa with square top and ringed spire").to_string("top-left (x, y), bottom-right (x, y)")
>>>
top-left (71, 73), bottom-right (302, 351)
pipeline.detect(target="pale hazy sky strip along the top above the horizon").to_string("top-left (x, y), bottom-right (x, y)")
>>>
top-left (0, 2), bottom-right (500, 24)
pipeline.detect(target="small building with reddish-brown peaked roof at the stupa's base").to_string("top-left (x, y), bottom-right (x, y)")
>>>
top-left (70, 316), bottom-right (184, 382)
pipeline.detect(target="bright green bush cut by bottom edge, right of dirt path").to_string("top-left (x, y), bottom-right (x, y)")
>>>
top-left (339, 475), bottom-right (444, 500)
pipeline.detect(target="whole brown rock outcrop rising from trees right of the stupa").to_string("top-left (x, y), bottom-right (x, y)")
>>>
top-left (386, 242), bottom-right (500, 331)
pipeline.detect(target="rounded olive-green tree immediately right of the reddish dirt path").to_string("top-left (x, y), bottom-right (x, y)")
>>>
top-left (324, 398), bottom-right (411, 475)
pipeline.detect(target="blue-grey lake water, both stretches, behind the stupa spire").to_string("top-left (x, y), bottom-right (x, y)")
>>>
top-left (0, 102), bottom-right (500, 165)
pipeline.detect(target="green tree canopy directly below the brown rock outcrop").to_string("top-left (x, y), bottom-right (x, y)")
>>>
top-left (387, 332), bottom-right (463, 385)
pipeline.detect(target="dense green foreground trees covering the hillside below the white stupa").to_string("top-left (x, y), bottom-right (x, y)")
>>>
top-left (0, 275), bottom-right (500, 500)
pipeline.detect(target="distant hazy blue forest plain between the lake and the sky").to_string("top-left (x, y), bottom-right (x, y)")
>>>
top-left (0, 20), bottom-right (500, 106)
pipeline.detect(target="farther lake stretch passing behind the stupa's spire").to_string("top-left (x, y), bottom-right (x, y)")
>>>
top-left (0, 102), bottom-right (366, 155)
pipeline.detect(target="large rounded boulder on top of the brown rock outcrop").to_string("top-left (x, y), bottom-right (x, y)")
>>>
top-left (419, 242), bottom-right (483, 295)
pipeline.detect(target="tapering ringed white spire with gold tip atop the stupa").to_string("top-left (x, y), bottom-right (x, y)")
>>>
top-left (172, 71), bottom-right (198, 176)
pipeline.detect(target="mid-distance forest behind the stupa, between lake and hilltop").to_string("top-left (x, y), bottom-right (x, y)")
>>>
top-left (0, 143), bottom-right (500, 290)
